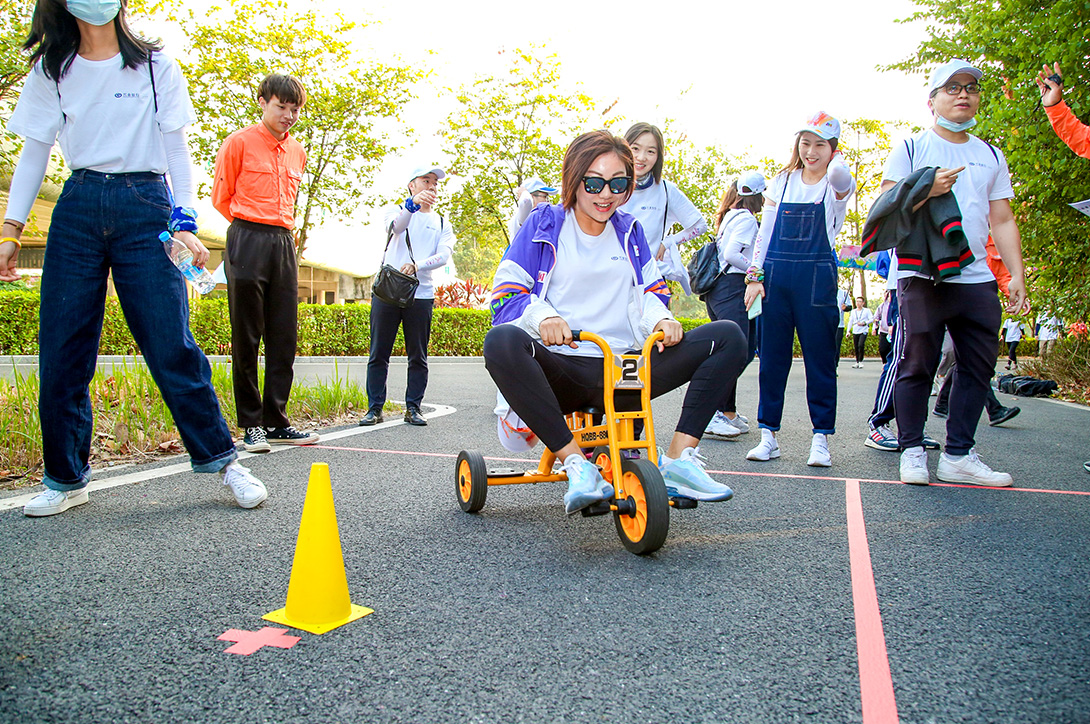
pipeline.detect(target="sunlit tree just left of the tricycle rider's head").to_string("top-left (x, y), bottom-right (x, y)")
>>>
top-left (439, 48), bottom-right (609, 283)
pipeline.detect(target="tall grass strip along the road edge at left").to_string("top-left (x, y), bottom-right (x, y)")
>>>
top-left (0, 363), bottom-right (397, 490)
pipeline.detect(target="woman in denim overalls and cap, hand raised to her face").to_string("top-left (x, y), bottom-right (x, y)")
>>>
top-left (746, 112), bottom-right (855, 468)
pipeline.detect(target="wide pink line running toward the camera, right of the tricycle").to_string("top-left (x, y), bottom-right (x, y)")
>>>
top-left (845, 480), bottom-right (900, 724)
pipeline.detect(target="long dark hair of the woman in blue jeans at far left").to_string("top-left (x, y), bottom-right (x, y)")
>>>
top-left (23, 0), bottom-right (162, 83)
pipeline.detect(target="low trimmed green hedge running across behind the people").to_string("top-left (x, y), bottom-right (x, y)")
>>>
top-left (0, 291), bottom-right (1037, 358)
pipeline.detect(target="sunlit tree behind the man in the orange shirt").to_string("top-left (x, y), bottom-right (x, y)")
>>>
top-left (142, 0), bottom-right (421, 256)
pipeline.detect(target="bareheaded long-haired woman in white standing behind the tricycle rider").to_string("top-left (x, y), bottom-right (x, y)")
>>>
top-left (621, 122), bottom-right (707, 294)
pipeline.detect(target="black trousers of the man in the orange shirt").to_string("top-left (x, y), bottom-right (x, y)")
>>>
top-left (225, 219), bottom-right (299, 427)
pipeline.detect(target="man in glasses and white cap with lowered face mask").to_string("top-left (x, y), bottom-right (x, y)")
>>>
top-left (882, 60), bottom-right (1029, 486)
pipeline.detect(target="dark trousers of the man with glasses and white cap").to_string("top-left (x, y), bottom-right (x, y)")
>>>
top-left (894, 277), bottom-right (1002, 455)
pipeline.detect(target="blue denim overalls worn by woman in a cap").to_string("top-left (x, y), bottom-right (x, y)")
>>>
top-left (758, 179), bottom-right (838, 435)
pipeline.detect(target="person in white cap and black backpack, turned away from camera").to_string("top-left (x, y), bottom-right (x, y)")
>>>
top-left (703, 171), bottom-right (764, 437)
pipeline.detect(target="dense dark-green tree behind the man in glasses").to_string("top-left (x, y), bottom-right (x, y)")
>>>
top-left (886, 0), bottom-right (1090, 319)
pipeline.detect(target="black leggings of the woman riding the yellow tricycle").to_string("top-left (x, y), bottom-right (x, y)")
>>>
top-left (484, 321), bottom-right (746, 451)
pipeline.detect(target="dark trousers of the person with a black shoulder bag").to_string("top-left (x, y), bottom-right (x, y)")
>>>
top-left (367, 298), bottom-right (435, 412)
